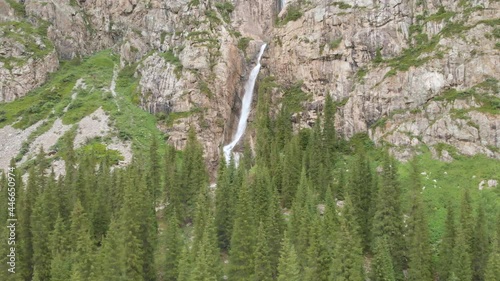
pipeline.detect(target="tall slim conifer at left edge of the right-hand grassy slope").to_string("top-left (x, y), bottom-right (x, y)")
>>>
top-left (407, 158), bottom-right (433, 281)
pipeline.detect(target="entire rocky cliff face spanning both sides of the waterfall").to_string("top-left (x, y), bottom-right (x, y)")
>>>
top-left (0, 0), bottom-right (500, 166)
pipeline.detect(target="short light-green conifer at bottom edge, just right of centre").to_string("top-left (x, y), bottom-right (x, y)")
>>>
top-left (278, 233), bottom-right (302, 281)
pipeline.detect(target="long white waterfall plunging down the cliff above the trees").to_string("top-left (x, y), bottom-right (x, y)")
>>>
top-left (223, 44), bottom-right (267, 163)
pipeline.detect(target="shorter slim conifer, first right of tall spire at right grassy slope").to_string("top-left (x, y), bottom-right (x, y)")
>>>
top-left (438, 203), bottom-right (456, 280)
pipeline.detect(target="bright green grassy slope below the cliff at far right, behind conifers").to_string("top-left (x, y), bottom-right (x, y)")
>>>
top-left (399, 148), bottom-right (500, 244)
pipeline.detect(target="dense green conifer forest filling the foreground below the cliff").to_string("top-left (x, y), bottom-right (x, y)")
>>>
top-left (0, 91), bottom-right (500, 281)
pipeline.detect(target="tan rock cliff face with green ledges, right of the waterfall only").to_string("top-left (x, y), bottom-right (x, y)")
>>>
top-left (268, 1), bottom-right (500, 160)
